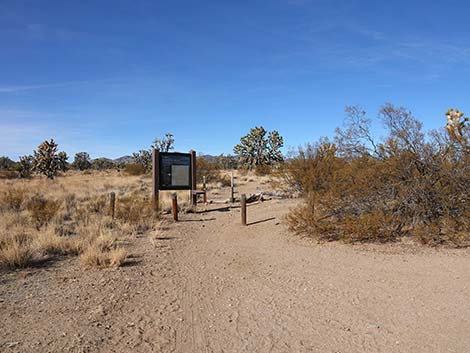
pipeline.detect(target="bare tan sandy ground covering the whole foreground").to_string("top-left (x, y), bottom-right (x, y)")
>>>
top-left (0, 183), bottom-right (470, 353)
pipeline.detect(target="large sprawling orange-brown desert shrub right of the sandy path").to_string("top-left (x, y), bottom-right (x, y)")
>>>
top-left (282, 105), bottom-right (470, 246)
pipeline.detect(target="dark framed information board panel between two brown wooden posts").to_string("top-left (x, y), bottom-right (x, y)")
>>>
top-left (158, 152), bottom-right (192, 190)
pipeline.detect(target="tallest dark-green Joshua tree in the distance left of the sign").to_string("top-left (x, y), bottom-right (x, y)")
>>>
top-left (34, 139), bottom-right (68, 179)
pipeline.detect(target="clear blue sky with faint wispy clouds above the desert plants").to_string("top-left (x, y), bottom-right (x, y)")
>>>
top-left (0, 0), bottom-right (470, 158)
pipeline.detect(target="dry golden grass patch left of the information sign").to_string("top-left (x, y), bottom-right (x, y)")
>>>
top-left (0, 171), bottom-right (159, 268)
